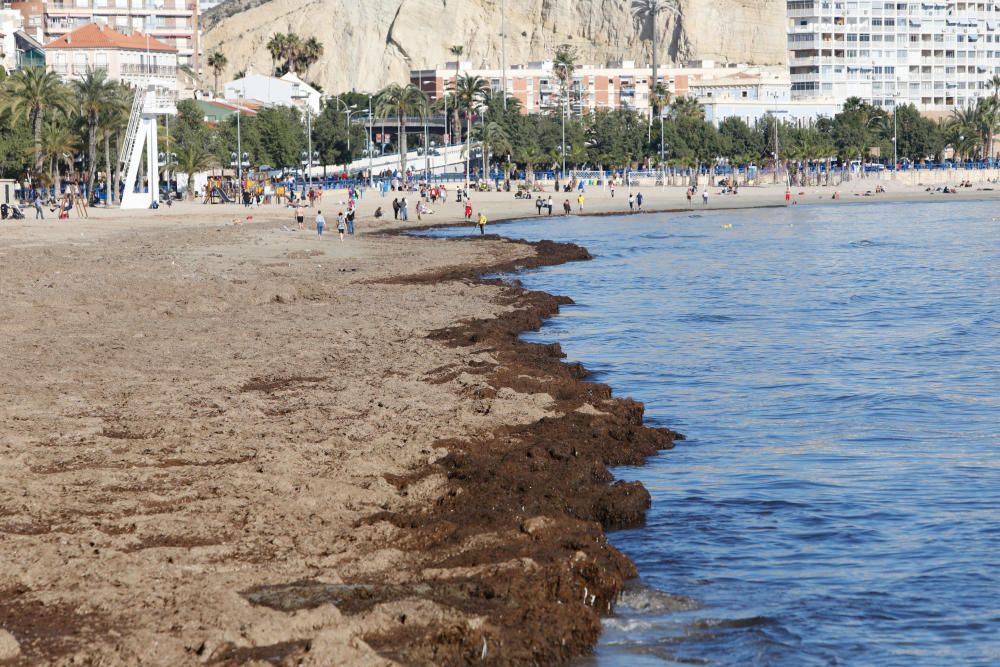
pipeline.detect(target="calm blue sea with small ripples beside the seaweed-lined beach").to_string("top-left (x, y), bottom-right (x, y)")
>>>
top-left (424, 203), bottom-right (1000, 666)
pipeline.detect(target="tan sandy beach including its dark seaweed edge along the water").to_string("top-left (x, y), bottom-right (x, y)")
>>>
top-left (0, 180), bottom-right (1000, 665)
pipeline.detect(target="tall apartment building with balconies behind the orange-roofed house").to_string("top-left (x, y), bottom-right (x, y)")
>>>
top-left (10, 0), bottom-right (200, 67)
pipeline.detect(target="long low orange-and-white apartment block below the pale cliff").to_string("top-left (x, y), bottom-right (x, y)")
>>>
top-left (410, 60), bottom-right (789, 114)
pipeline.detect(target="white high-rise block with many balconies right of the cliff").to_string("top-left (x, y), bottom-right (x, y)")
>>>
top-left (787, 0), bottom-right (1000, 111)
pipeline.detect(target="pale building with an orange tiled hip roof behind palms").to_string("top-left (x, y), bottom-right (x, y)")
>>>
top-left (45, 23), bottom-right (177, 98)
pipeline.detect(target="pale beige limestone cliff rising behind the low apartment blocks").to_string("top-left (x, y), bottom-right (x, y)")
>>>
top-left (204, 0), bottom-right (787, 93)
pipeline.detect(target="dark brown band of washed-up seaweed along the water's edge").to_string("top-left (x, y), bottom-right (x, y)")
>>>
top-left (350, 239), bottom-right (683, 664)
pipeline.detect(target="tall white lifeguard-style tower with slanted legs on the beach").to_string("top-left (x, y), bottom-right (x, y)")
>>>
top-left (119, 86), bottom-right (177, 209)
